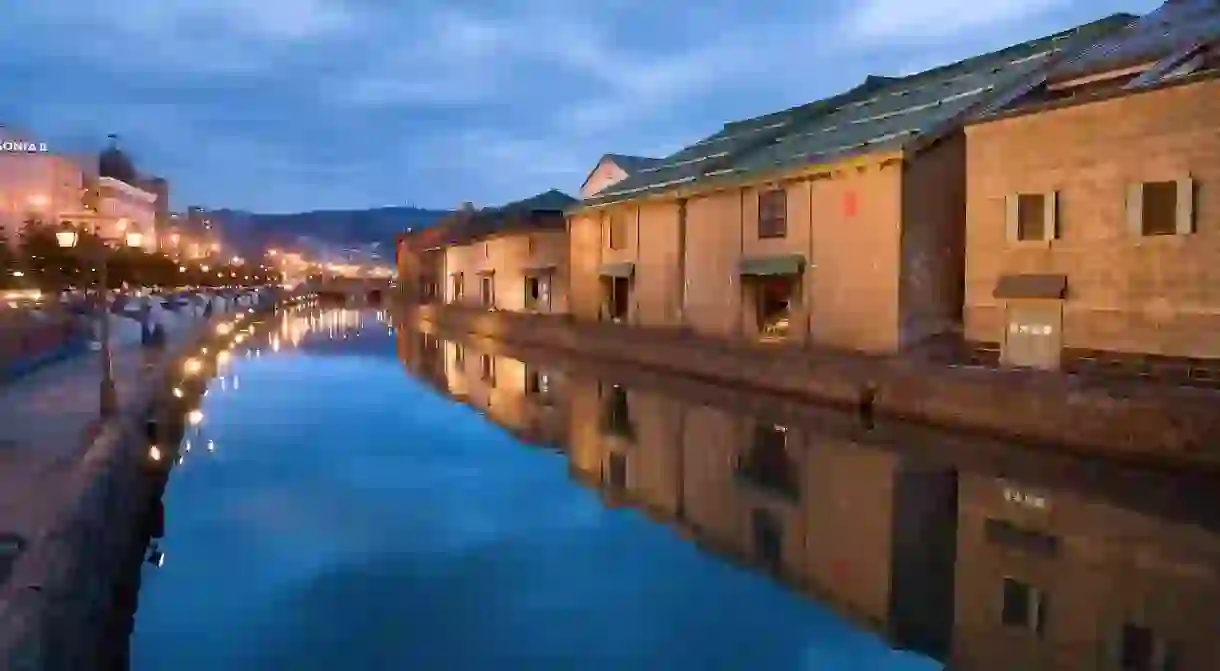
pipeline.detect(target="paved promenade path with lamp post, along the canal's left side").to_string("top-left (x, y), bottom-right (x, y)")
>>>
top-left (0, 317), bottom-right (198, 538)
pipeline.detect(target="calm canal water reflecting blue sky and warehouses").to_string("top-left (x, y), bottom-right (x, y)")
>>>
top-left (132, 307), bottom-right (1220, 671)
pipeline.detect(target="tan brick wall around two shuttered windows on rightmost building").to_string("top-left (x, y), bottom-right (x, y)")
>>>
top-left (965, 79), bottom-right (1220, 357)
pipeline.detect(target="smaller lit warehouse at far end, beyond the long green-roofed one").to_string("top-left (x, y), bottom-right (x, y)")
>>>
top-left (397, 190), bottom-right (576, 314)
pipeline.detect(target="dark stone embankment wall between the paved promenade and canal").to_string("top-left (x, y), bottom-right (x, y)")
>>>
top-left (0, 301), bottom-right (280, 671)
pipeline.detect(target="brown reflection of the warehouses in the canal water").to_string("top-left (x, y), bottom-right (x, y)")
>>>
top-left (397, 328), bottom-right (1220, 671)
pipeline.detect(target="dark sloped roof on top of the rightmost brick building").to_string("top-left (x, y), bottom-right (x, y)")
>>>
top-left (1049, 0), bottom-right (1220, 81)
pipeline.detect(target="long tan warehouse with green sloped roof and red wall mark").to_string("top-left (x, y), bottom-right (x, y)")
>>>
top-left (570, 15), bottom-right (1135, 351)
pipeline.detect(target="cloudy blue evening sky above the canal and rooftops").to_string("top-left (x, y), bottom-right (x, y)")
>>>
top-left (0, 0), bottom-right (1160, 212)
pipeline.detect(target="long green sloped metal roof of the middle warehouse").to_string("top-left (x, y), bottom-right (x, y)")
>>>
top-left (582, 15), bottom-right (1136, 205)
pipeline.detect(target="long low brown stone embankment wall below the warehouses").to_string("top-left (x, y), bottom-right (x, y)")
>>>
top-left (403, 305), bottom-right (1220, 470)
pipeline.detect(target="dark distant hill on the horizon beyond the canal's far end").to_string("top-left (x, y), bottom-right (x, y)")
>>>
top-left (210, 207), bottom-right (449, 256)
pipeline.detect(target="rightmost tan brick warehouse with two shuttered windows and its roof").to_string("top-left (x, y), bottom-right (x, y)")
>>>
top-left (965, 0), bottom-right (1220, 372)
